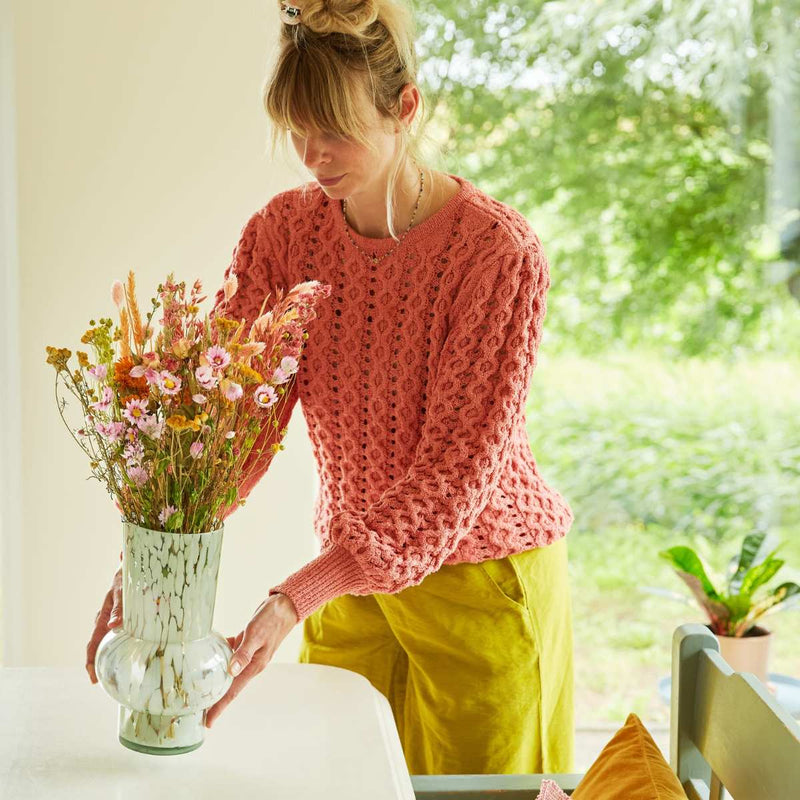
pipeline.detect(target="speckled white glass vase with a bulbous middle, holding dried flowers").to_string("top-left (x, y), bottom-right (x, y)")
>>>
top-left (95, 521), bottom-right (233, 755)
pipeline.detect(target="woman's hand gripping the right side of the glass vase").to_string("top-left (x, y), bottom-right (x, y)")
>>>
top-left (205, 594), bottom-right (299, 728)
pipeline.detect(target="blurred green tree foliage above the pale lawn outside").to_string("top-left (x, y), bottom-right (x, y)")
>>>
top-left (417, 0), bottom-right (800, 355)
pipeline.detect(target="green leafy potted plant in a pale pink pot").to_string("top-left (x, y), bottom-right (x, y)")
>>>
top-left (650, 533), bottom-right (800, 684)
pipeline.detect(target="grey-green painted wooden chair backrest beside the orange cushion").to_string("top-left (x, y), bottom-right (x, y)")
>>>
top-left (670, 623), bottom-right (800, 800)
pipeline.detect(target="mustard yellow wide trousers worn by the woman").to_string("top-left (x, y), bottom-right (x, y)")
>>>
top-left (299, 537), bottom-right (574, 775)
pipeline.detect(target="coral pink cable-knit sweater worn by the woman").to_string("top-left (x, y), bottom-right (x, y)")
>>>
top-left (216, 175), bottom-right (573, 620)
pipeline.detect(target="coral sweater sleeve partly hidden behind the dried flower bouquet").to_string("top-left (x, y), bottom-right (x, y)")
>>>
top-left (209, 195), bottom-right (298, 517)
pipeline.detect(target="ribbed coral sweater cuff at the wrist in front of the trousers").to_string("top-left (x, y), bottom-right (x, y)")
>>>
top-left (269, 544), bottom-right (367, 622)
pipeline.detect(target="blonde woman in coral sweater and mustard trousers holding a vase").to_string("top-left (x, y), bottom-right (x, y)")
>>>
top-left (87, 0), bottom-right (573, 774)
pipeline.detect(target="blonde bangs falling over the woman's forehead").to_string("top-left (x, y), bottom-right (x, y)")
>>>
top-left (264, 51), bottom-right (368, 143)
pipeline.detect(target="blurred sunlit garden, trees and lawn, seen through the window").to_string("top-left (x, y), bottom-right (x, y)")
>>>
top-left (413, 0), bottom-right (800, 726)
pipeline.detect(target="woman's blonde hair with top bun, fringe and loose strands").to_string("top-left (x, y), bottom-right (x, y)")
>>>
top-left (263, 0), bottom-right (438, 239)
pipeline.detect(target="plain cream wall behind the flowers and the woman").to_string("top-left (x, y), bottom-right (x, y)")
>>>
top-left (0, 0), bottom-right (317, 668)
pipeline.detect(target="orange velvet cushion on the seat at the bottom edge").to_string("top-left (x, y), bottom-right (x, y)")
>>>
top-left (572, 714), bottom-right (686, 800)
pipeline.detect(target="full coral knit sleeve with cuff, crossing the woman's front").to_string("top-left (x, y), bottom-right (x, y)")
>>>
top-left (270, 231), bottom-right (550, 620)
